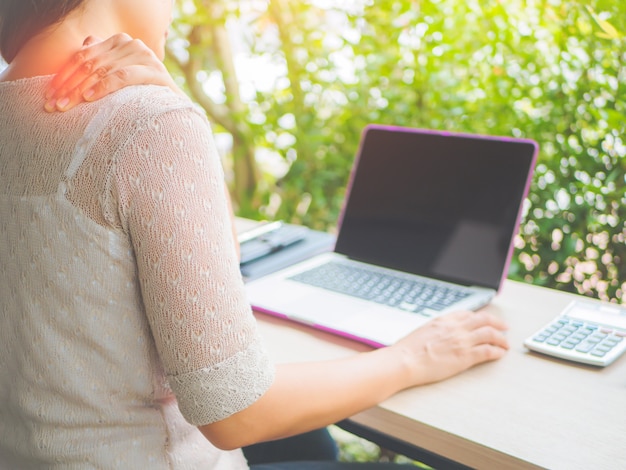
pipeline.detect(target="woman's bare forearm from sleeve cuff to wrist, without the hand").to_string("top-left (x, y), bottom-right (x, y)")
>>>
top-left (200, 348), bottom-right (410, 449)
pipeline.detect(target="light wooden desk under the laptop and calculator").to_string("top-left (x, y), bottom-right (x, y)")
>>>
top-left (252, 281), bottom-right (626, 470)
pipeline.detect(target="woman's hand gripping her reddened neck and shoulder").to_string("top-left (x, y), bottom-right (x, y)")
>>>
top-left (45, 33), bottom-right (184, 112)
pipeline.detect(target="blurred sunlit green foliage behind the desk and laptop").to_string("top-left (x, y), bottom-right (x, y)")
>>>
top-left (168, 0), bottom-right (626, 302)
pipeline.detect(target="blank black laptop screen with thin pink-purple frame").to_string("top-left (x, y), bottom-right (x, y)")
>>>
top-left (335, 125), bottom-right (537, 289)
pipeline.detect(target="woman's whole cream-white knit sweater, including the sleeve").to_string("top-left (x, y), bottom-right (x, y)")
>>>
top-left (0, 77), bottom-right (274, 470)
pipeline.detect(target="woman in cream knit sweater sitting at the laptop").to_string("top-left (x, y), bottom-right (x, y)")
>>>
top-left (0, 0), bottom-right (508, 469)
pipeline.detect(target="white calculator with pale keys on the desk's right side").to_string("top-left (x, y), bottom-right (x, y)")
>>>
top-left (524, 300), bottom-right (626, 367)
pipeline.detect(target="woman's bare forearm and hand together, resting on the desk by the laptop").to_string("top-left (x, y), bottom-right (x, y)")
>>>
top-left (200, 311), bottom-right (509, 449)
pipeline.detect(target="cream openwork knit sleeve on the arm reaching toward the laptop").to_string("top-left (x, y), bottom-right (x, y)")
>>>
top-left (109, 103), bottom-right (273, 425)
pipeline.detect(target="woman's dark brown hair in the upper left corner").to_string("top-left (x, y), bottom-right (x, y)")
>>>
top-left (0, 0), bottom-right (85, 63)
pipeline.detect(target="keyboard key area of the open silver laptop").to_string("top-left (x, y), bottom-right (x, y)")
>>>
top-left (289, 261), bottom-right (470, 316)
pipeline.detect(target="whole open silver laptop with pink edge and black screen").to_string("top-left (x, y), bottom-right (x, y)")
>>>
top-left (246, 124), bottom-right (538, 347)
